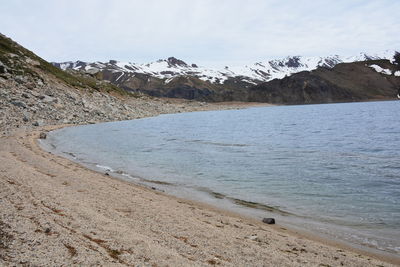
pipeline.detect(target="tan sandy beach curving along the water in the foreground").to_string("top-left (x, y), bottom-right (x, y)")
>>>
top-left (0, 126), bottom-right (400, 266)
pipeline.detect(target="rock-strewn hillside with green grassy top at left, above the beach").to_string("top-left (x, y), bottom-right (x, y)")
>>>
top-left (0, 34), bottom-right (245, 134)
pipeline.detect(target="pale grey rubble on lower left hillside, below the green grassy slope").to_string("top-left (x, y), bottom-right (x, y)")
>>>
top-left (0, 68), bottom-right (265, 136)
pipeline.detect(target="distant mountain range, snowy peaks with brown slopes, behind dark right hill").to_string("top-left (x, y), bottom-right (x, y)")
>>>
top-left (53, 51), bottom-right (394, 103)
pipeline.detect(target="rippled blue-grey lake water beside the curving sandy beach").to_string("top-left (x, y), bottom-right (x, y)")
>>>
top-left (43, 101), bottom-right (400, 253)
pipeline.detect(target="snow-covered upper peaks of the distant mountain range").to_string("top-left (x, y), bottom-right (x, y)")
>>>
top-left (53, 50), bottom-right (394, 86)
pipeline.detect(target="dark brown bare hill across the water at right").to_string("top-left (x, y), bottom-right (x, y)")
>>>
top-left (246, 60), bottom-right (400, 104)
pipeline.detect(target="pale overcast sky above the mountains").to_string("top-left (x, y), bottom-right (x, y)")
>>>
top-left (0, 0), bottom-right (400, 66)
